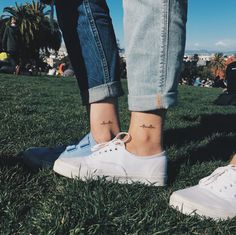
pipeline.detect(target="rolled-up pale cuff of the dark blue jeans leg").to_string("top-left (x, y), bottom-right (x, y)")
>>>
top-left (82, 81), bottom-right (124, 105)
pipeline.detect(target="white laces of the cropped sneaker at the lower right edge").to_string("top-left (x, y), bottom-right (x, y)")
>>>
top-left (199, 165), bottom-right (236, 186)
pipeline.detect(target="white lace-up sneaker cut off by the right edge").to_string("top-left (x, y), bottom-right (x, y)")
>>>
top-left (170, 165), bottom-right (236, 220)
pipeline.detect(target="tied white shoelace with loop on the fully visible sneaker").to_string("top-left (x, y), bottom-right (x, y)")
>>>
top-left (91, 132), bottom-right (131, 152)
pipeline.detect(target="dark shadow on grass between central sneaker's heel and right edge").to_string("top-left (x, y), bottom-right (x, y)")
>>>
top-left (165, 114), bottom-right (236, 183)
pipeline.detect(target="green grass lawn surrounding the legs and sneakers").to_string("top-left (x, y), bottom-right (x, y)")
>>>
top-left (0, 75), bottom-right (236, 235)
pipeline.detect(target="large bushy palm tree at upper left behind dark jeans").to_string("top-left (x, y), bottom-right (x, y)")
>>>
top-left (4, 0), bottom-right (62, 63)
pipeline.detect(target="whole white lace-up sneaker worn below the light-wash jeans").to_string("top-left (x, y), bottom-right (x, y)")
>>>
top-left (53, 133), bottom-right (167, 186)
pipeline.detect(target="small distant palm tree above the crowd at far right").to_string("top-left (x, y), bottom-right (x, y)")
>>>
top-left (209, 52), bottom-right (225, 77)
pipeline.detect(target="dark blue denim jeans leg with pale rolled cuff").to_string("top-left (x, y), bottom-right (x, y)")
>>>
top-left (56, 0), bottom-right (123, 105)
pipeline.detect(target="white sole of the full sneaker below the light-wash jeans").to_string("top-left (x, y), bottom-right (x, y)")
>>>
top-left (53, 159), bottom-right (167, 186)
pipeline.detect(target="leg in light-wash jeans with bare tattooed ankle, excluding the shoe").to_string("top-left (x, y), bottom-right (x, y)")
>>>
top-left (124, 0), bottom-right (187, 156)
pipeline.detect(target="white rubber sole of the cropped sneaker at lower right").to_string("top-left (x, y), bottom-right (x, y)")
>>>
top-left (169, 192), bottom-right (235, 221)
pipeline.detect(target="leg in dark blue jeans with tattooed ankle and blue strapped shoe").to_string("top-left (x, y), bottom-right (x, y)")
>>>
top-left (23, 0), bottom-right (123, 168)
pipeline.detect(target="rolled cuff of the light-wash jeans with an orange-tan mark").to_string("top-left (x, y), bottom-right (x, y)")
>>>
top-left (128, 91), bottom-right (178, 112)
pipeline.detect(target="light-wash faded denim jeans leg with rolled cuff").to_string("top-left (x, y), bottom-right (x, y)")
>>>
top-left (123, 0), bottom-right (187, 111)
